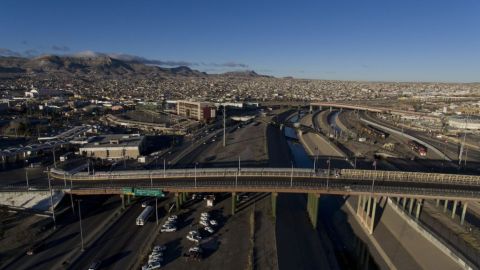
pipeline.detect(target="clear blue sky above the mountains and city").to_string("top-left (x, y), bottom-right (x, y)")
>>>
top-left (0, 0), bottom-right (480, 82)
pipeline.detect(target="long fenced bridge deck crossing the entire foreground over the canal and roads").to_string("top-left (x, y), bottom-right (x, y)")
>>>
top-left (0, 168), bottom-right (480, 201)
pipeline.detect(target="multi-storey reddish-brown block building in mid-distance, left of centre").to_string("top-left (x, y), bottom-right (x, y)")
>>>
top-left (177, 100), bottom-right (216, 122)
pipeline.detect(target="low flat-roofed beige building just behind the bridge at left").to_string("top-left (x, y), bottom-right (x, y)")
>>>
top-left (79, 134), bottom-right (145, 159)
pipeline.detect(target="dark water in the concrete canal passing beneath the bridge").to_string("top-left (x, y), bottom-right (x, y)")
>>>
top-left (285, 113), bottom-right (379, 269)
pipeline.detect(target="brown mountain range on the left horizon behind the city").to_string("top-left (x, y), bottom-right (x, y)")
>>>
top-left (0, 55), bottom-right (207, 77)
